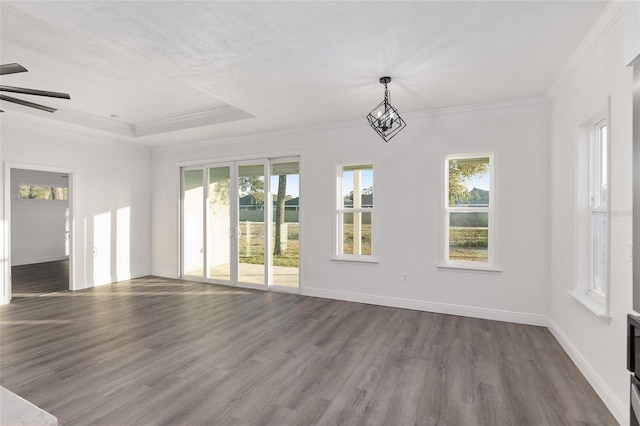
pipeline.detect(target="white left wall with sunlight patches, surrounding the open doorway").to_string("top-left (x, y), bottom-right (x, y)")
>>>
top-left (1, 112), bottom-right (151, 300)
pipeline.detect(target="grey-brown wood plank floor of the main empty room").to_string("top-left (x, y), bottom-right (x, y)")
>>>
top-left (0, 277), bottom-right (617, 426)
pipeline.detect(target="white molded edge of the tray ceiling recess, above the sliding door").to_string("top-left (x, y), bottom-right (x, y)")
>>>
top-left (133, 105), bottom-right (255, 137)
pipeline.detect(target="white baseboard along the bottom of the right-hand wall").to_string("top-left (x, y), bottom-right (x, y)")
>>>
top-left (547, 318), bottom-right (629, 425)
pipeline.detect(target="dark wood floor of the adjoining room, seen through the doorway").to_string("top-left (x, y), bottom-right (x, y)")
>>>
top-left (11, 260), bottom-right (69, 300)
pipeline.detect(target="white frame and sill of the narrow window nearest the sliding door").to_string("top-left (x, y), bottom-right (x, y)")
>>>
top-left (331, 161), bottom-right (379, 263)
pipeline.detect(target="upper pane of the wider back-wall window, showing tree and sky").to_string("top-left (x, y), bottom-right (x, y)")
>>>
top-left (447, 157), bottom-right (490, 207)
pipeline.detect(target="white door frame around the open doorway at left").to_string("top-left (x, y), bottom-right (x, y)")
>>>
top-left (1, 161), bottom-right (77, 304)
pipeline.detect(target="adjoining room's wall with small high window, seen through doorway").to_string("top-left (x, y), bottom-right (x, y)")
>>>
top-left (11, 169), bottom-right (69, 266)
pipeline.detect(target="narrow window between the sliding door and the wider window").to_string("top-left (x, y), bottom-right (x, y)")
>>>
top-left (336, 164), bottom-right (374, 259)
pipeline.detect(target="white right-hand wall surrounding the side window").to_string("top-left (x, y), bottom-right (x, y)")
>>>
top-left (549, 6), bottom-right (632, 424)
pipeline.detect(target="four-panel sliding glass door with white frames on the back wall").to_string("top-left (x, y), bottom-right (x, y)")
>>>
top-left (182, 158), bottom-right (300, 291)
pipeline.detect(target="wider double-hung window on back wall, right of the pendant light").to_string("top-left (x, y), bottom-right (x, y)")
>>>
top-left (443, 153), bottom-right (493, 268)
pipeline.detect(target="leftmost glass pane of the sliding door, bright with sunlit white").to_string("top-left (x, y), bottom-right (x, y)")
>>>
top-left (182, 170), bottom-right (204, 277)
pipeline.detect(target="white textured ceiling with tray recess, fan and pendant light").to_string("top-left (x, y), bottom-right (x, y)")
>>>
top-left (0, 1), bottom-right (606, 145)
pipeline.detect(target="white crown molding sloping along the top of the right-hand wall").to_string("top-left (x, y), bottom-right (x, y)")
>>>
top-left (547, 0), bottom-right (624, 99)
